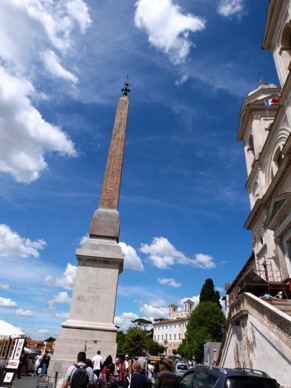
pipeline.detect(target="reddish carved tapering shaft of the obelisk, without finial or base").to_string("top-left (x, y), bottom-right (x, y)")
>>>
top-left (99, 96), bottom-right (129, 210)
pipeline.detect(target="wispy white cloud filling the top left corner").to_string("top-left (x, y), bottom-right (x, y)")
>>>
top-left (0, 0), bottom-right (91, 72)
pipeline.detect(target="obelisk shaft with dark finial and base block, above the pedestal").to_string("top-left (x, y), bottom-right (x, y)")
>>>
top-left (89, 77), bottom-right (130, 241)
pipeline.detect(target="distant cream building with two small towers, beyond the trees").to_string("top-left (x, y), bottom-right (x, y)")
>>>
top-left (153, 299), bottom-right (194, 355)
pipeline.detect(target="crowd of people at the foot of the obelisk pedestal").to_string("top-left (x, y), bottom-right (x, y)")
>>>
top-left (62, 350), bottom-right (179, 388)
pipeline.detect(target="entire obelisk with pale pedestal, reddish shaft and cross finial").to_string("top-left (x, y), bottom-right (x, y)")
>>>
top-left (49, 82), bottom-right (130, 377)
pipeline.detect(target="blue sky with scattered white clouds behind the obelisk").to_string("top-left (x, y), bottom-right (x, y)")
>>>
top-left (0, 0), bottom-right (278, 339)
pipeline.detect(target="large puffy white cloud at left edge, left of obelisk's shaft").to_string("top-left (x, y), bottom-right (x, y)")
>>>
top-left (0, 67), bottom-right (77, 183)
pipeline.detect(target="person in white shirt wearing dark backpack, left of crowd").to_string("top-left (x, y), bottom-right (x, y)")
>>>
top-left (62, 352), bottom-right (94, 388)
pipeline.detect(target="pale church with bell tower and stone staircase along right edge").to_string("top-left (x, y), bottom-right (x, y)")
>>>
top-left (218, 0), bottom-right (291, 387)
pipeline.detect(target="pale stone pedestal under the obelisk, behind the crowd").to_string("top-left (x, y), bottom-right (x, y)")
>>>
top-left (48, 238), bottom-right (124, 378)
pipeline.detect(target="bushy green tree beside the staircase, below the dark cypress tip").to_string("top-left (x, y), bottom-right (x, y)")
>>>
top-left (178, 302), bottom-right (225, 363)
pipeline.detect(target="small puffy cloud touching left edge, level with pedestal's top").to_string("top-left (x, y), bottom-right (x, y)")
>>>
top-left (0, 224), bottom-right (46, 258)
